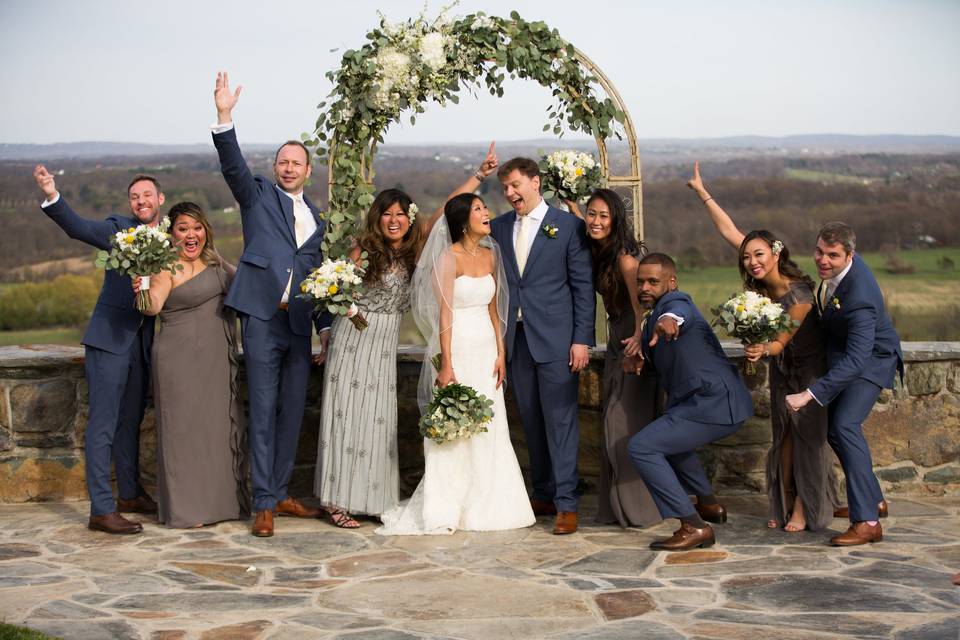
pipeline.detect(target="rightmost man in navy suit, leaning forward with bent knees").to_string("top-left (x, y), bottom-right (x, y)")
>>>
top-left (786, 222), bottom-right (903, 546)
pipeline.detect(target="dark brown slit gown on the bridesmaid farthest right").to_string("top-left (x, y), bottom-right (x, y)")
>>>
top-left (767, 282), bottom-right (839, 531)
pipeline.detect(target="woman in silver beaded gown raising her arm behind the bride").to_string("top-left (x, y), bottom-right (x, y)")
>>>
top-left (313, 143), bottom-right (497, 529)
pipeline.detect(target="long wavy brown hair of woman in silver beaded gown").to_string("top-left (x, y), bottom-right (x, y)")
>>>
top-left (357, 189), bottom-right (420, 285)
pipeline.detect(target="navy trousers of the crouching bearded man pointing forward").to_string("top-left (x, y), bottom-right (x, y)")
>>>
top-left (627, 413), bottom-right (743, 518)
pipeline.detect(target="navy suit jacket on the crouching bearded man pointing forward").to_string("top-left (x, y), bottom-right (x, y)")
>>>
top-left (643, 291), bottom-right (753, 425)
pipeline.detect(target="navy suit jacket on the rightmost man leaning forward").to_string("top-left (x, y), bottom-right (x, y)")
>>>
top-left (810, 254), bottom-right (903, 405)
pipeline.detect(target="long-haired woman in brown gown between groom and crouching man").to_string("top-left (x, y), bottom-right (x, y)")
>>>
top-left (567, 189), bottom-right (661, 527)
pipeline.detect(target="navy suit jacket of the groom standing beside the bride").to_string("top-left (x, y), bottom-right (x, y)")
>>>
top-left (490, 207), bottom-right (597, 362)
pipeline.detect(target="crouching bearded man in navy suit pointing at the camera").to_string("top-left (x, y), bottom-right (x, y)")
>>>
top-left (627, 253), bottom-right (753, 551)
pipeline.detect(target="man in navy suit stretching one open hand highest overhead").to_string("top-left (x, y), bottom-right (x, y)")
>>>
top-left (213, 72), bottom-right (330, 537)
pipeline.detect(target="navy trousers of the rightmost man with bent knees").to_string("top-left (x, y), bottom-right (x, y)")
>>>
top-left (827, 380), bottom-right (883, 522)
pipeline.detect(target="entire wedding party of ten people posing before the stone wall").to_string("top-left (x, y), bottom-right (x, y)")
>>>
top-left (28, 73), bottom-right (903, 551)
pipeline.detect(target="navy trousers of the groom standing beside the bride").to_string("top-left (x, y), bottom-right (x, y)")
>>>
top-left (508, 323), bottom-right (580, 511)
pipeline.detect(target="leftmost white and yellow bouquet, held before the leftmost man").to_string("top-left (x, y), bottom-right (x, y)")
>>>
top-left (94, 218), bottom-right (183, 311)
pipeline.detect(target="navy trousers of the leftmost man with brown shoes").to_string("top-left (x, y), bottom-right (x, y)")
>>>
top-left (84, 329), bottom-right (150, 516)
